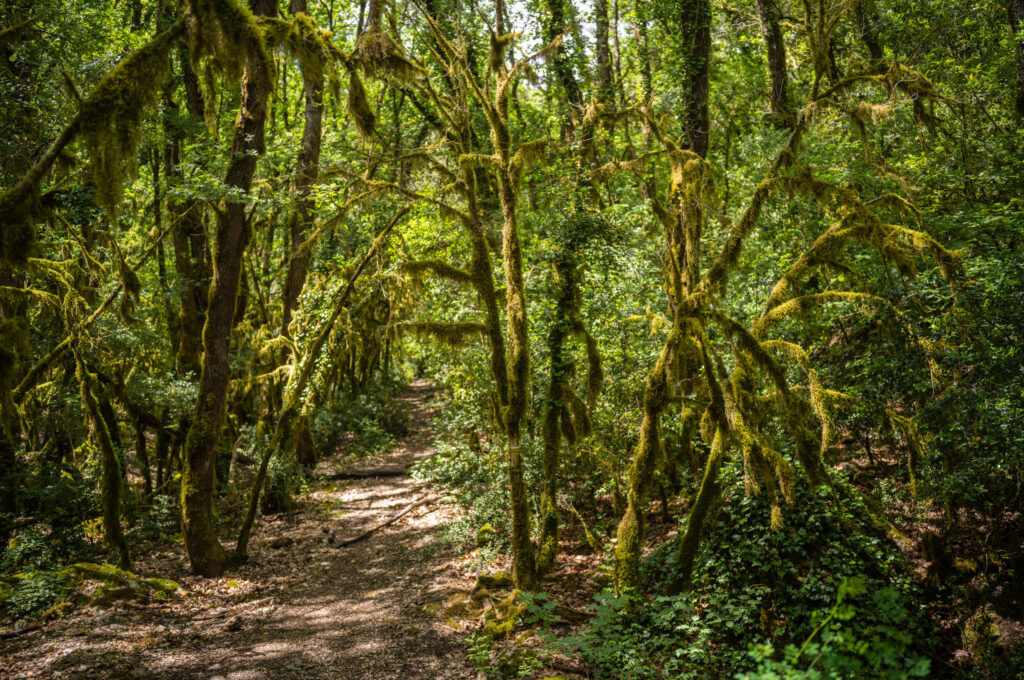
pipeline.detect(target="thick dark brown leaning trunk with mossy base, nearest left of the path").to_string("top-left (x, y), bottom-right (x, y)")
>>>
top-left (181, 0), bottom-right (278, 577)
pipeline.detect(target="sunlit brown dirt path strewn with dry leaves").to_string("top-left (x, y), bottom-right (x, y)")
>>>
top-left (0, 382), bottom-right (476, 680)
